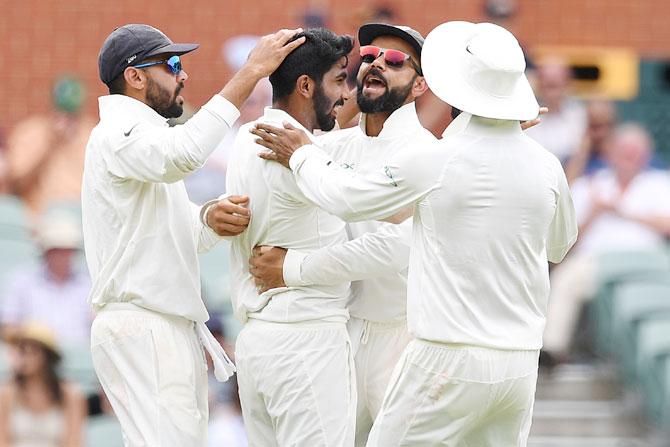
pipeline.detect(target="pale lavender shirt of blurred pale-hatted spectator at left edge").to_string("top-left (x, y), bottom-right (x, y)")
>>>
top-left (0, 266), bottom-right (92, 346)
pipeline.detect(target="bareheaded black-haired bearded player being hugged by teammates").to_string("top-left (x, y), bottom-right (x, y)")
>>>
top-left (226, 29), bottom-right (356, 447)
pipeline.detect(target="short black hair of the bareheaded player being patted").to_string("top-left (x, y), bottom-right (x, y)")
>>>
top-left (270, 28), bottom-right (354, 102)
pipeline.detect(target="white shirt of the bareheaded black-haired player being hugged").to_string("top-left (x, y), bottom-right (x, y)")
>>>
top-left (226, 107), bottom-right (349, 323)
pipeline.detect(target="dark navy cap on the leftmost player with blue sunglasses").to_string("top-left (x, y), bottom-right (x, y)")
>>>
top-left (98, 24), bottom-right (200, 84)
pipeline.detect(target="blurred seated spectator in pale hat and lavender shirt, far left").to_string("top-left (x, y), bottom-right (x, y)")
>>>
top-left (0, 211), bottom-right (92, 346)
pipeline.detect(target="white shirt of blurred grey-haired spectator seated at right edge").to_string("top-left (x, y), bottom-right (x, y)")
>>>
top-left (572, 169), bottom-right (670, 255)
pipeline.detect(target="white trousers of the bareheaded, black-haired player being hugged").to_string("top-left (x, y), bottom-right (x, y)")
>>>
top-left (235, 320), bottom-right (356, 447)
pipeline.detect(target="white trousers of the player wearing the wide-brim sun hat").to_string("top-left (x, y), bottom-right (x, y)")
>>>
top-left (367, 340), bottom-right (539, 447)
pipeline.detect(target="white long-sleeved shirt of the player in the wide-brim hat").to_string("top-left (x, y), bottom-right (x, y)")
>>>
top-left (290, 114), bottom-right (577, 350)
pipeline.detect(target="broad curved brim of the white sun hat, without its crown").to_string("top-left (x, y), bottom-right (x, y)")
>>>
top-left (421, 22), bottom-right (540, 121)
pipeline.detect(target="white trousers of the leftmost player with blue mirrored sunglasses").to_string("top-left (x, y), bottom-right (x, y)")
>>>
top-left (91, 304), bottom-right (208, 447)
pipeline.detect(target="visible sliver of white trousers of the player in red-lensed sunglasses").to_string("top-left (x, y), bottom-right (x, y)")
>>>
top-left (348, 317), bottom-right (411, 446)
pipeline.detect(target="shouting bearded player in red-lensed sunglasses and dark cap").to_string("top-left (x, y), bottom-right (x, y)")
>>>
top-left (251, 23), bottom-right (437, 446)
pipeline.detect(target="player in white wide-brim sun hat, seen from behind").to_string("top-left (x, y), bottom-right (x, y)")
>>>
top-left (252, 22), bottom-right (577, 447)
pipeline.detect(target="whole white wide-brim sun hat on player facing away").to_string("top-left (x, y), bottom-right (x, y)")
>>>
top-left (421, 22), bottom-right (540, 121)
